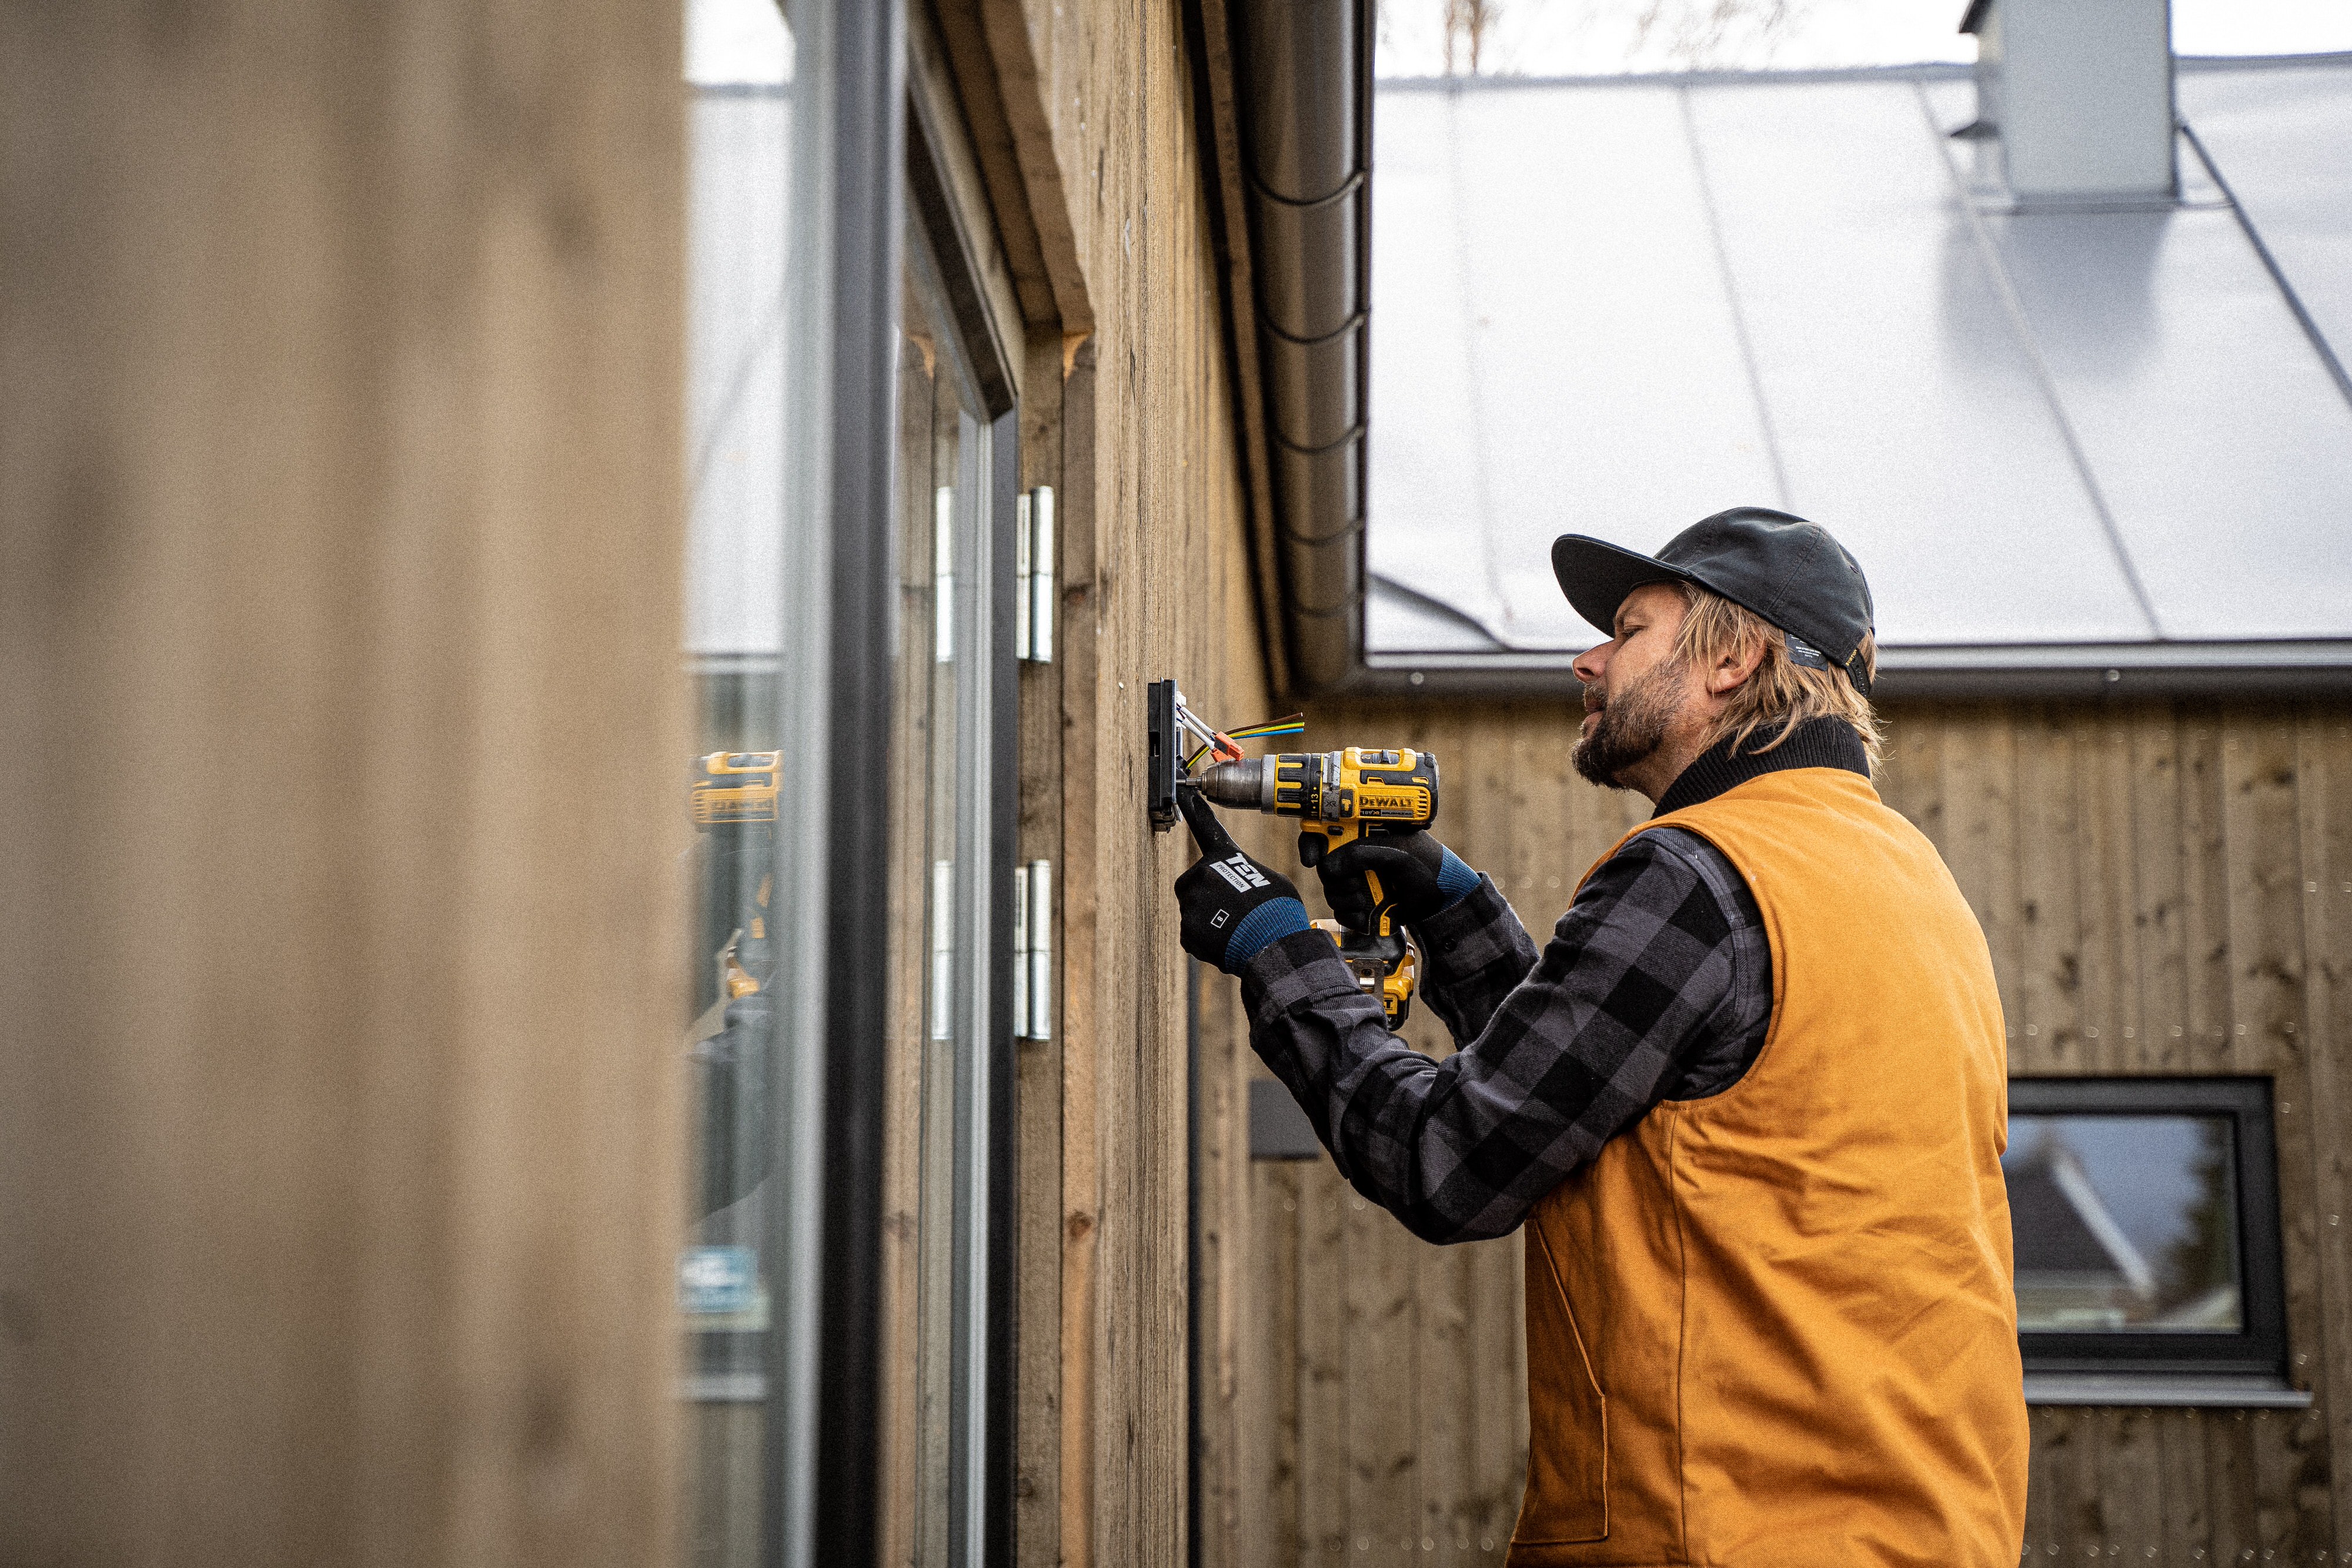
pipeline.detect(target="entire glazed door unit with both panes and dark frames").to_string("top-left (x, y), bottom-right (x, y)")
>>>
top-left (677, 0), bottom-right (1018, 1568)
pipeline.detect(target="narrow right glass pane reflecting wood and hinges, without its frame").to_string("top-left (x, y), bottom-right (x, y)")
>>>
top-left (882, 239), bottom-right (1002, 1563)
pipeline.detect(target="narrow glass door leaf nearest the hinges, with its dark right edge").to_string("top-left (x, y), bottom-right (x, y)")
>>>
top-left (884, 135), bottom-right (1016, 1566)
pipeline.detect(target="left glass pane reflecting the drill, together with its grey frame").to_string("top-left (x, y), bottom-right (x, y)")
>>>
top-left (675, 0), bottom-right (884, 1568)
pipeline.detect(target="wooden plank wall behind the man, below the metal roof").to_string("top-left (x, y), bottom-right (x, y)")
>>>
top-left (1211, 703), bottom-right (2352, 1568)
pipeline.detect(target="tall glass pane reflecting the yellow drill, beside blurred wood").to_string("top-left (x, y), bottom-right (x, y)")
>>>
top-left (677, 0), bottom-right (793, 1568)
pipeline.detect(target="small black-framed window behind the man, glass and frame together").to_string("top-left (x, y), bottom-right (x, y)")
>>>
top-left (2002, 1079), bottom-right (2286, 1396)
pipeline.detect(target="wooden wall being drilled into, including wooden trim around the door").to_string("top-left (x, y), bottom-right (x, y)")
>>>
top-left (936, 0), bottom-right (1279, 1568)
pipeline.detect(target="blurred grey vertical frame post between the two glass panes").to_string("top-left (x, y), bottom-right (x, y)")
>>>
top-left (781, 0), bottom-right (906, 1568)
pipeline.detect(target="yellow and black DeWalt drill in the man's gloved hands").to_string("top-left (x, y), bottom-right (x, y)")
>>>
top-left (1192, 745), bottom-right (1437, 1029)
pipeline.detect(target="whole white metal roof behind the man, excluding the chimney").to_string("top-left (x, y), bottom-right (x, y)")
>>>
top-left (1367, 56), bottom-right (2352, 684)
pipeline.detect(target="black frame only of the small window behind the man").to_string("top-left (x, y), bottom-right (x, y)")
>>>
top-left (2009, 1076), bottom-right (2286, 1382)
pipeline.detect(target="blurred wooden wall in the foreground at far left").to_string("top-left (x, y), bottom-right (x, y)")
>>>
top-left (0, 0), bottom-right (691, 1568)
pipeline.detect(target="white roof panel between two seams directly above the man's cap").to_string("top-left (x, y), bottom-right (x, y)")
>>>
top-left (1684, 80), bottom-right (2152, 644)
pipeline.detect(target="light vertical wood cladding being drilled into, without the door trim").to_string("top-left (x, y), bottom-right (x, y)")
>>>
top-left (1040, 34), bottom-right (1268, 1568)
